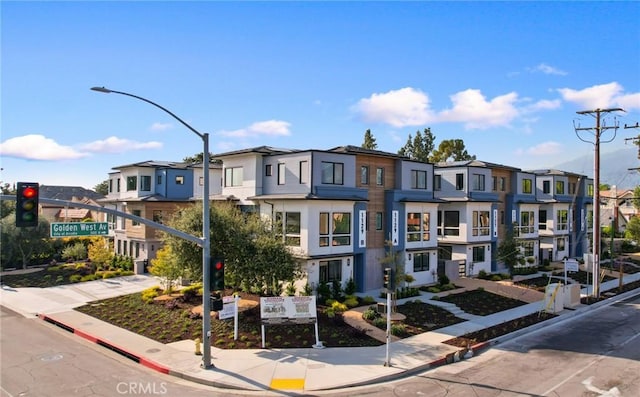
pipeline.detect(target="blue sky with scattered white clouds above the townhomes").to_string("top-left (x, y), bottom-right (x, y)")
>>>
top-left (0, 1), bottom-right (640, 188)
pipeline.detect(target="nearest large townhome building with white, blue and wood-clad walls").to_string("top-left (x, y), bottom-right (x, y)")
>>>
top-left (215, 146), bottom-right (437, 291)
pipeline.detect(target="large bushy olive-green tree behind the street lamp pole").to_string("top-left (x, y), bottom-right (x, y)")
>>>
top-left (164, 203), bottom-right (302, 293)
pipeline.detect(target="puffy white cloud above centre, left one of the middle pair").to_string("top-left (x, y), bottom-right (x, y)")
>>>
top-left (352, 87), bottom-right (433, 127)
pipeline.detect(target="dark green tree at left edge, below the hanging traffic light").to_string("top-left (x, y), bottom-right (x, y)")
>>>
top-left (0, 214), bottom-right (50, 269)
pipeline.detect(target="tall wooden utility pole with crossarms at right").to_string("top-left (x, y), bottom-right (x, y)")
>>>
top-left (574, 108), bottom-right (624, 299)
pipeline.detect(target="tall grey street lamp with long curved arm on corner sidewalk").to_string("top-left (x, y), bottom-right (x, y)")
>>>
top-left (91, 87), bottom-right (213, 368)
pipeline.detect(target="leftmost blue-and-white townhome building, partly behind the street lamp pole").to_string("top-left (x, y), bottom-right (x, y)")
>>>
top-left (100, 161), bottom-right (221, 261)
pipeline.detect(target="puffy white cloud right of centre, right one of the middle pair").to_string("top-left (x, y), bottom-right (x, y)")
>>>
top-left (438, 89), bottom-right (519, 129)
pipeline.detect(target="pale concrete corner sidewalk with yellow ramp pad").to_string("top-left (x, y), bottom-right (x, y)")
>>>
top-left (0, 273), bottom-right (640, 392)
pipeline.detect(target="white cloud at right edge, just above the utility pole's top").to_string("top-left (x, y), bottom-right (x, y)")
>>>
top-left (558, 81), bottom-right (640, 109)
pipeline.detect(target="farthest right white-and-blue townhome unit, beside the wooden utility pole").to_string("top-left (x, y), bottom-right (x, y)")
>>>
top-left (531, 169), bottom-right (593, 261)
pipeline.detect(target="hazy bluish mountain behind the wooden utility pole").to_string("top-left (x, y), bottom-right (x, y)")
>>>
top-left (552, 148), bottom-right (640, 190)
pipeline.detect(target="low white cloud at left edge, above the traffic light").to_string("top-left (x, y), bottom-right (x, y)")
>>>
top-left (0, 134), bottom-right (89, 160)
